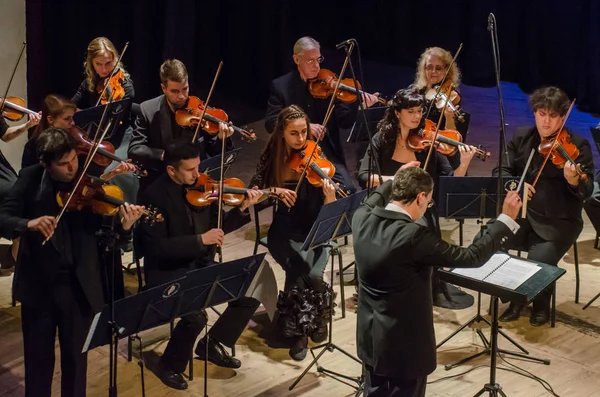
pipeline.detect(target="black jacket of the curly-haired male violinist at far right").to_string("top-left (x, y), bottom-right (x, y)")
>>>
top-left (494, 127), bottom-right (594, 240)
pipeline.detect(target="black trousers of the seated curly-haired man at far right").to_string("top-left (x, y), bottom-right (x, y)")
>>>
top-left (508, 219), bottom-right (581, 310)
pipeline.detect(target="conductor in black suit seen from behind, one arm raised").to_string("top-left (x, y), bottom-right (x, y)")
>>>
top-left (352, 167), bottom-right (521, 397)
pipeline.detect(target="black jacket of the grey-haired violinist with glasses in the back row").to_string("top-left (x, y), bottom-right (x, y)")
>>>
top-left (265, 69), bottom-right (358, 163)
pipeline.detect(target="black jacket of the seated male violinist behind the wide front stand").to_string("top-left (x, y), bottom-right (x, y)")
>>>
top-left (136, 173), bottom-right (250, 286)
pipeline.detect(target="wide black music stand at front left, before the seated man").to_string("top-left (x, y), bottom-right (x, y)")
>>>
top-left (83, 253), bottom-right (266, 397)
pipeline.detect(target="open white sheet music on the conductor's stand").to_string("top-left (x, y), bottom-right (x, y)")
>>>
top-left (452, 254), bottom-right (541, 290)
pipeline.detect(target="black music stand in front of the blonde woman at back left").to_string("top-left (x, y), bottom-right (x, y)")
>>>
top-left (73, 98), bottom-right (133, 140)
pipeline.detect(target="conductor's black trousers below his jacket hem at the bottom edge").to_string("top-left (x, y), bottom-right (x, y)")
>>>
top-left (364, 365), bottom-right (427, 397)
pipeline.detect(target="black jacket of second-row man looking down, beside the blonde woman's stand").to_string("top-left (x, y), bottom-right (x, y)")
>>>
top-left (128, 95), bottom-right (233, 192)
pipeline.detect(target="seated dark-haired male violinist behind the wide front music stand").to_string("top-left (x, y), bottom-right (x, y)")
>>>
top-left (136, 137), bottom-right (262, 390)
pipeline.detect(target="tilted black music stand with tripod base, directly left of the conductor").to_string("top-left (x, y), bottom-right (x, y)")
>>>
top-left (289, 190), bottom-right (367, 393)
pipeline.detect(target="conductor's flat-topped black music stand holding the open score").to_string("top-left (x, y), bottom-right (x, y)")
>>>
top-left (439, 253), bottom-right (566, 397)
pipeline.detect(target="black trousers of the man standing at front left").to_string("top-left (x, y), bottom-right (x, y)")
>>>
top-left (21, 276), bottom-right (92, 397)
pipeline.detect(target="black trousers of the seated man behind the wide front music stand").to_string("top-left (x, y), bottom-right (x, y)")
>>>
top-left (161, 297), bottom-right (260, 373)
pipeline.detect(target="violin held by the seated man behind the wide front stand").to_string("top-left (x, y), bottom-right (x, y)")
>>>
top-left (185, 174), bottom-right (278, 207)
